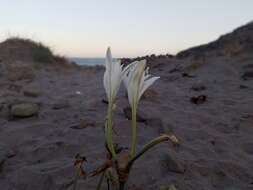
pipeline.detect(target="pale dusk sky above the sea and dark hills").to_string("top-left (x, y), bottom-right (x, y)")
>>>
top-left (0, 0), bottom-right (253, 57)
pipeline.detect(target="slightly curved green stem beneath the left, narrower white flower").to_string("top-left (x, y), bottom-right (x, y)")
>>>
top-left (105, 103), bottom-right (116, 160)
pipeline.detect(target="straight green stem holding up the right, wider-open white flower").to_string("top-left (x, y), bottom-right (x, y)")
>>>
top-left (130, 103), bottom-right (137, 158)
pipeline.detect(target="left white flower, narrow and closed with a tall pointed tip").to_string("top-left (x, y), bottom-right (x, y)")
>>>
top-left (104, 48), bottom-right (124, 103)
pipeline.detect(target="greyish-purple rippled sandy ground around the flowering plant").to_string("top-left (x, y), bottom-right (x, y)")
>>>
top-left (0, 53), bottom-right (253, 190)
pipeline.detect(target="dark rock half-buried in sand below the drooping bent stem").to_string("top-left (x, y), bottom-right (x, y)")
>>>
top-left (160, 151), bottom-right (185, 174)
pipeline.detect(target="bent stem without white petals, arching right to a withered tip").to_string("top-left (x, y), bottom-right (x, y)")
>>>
top-left (127, 135), bottom-right (170, 169)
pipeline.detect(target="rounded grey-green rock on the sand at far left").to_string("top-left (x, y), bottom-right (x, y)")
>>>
top-left (11, 103), bottom-right (39, 118)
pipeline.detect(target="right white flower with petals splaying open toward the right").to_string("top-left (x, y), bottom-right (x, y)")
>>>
top-left (124, 60), bottom-right (160, 106)
